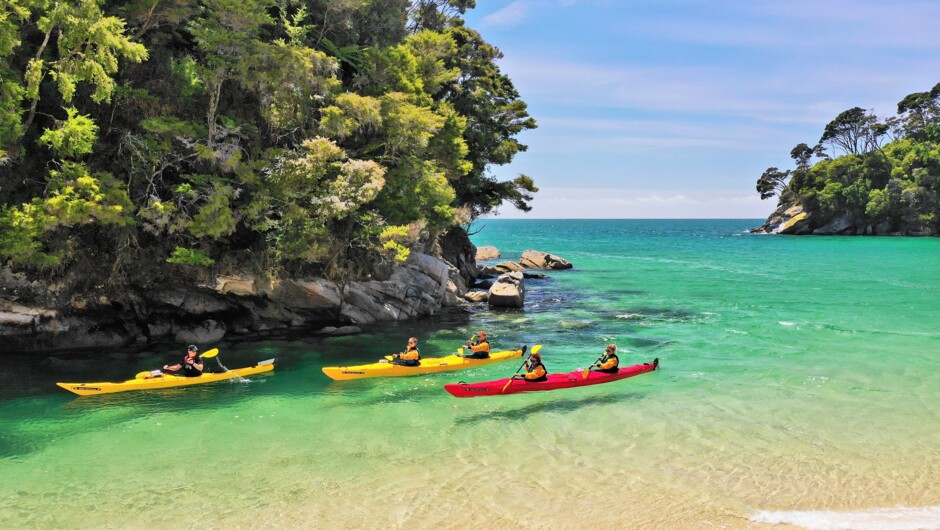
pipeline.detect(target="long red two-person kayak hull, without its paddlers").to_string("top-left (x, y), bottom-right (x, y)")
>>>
top-left (444, 358), bottom-right (659, 397)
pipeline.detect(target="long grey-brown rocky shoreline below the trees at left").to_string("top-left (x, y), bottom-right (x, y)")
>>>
top-left (0, 253), bottom-right (460, 353)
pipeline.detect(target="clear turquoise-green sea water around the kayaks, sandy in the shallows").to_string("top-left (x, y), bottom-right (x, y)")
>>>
top-left (0, 220), bottom-right (940, 528)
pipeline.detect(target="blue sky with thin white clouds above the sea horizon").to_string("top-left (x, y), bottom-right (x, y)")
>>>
top-left (464, 0), bottom-right (940, 218)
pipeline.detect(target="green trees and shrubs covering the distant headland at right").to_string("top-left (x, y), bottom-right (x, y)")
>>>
top-left (757, 84), bottom-right (940, 234)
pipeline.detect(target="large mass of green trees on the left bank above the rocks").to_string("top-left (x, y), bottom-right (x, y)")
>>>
top-left (0, 0), bottom-right (537, 282)
